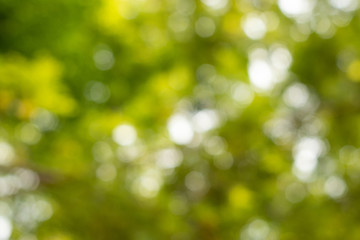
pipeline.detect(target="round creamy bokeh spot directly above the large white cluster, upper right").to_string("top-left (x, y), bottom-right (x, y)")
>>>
top-left (242, 14), bottom-right (267, 40)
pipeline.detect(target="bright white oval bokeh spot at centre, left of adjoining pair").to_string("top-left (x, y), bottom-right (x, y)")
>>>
top-left (167, 114), bottom-right (194, 145)
